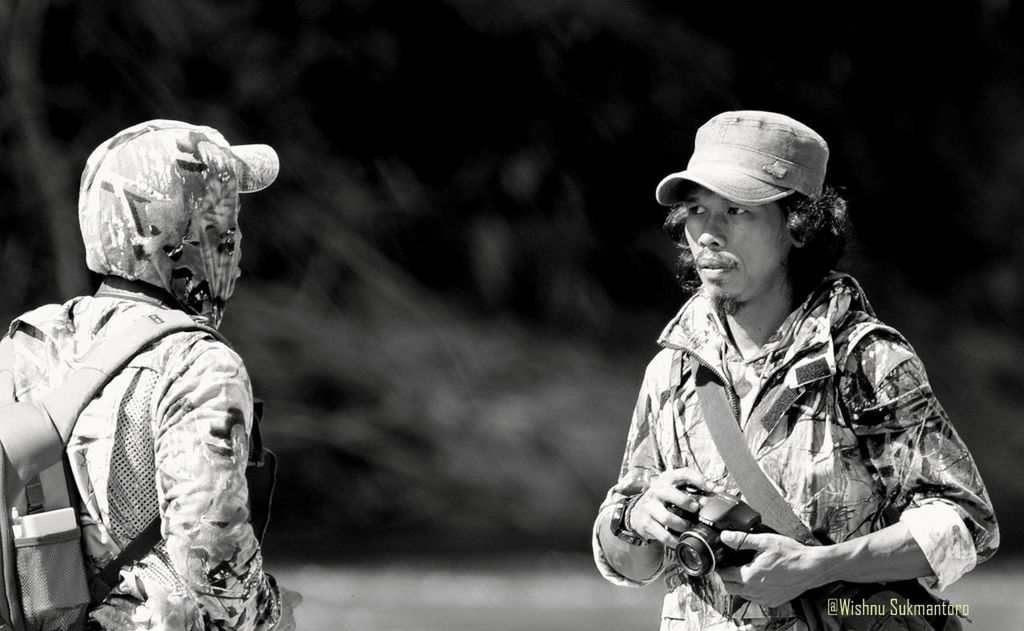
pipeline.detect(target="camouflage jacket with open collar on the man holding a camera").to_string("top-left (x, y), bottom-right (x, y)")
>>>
top-left (593, 275), bottom-right (998, 631)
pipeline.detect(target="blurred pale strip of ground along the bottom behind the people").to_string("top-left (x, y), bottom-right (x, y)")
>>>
top-left (271, 554), bottom-right (1024, 631)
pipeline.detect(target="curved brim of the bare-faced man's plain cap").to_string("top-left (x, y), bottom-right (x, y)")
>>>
top-left (654, 167), bottom-right (794, 206)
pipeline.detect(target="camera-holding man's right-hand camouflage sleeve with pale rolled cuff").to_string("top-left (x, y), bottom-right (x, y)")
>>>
top-left (840, 332), bottom-right (999, 589)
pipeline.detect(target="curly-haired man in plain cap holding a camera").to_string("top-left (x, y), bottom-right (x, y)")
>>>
top-left (593, 111), bottom-right (998, 631)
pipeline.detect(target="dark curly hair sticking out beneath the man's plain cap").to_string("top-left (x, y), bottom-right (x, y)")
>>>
top-left (664, 186), bottom-right (850, 302)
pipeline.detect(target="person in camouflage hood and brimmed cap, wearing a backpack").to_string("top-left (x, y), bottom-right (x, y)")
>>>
top-left (4, 120), bottom-right (298, 631)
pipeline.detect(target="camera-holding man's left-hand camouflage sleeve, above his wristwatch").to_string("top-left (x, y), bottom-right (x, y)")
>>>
top-left (591, 350), bottom-right (673, 586)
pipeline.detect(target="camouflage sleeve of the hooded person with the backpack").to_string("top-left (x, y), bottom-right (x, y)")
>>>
top-left (154, 339), bottom-right (281, 631)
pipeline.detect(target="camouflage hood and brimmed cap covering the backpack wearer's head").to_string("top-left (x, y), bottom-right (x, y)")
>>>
top-left (79, 120), bottom-right (280, 325)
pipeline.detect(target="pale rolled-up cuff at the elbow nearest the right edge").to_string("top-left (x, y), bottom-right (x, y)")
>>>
top-left (899, 501), bottom-right (978, 590)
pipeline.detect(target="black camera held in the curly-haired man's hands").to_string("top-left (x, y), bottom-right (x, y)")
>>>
top-left (667, 485), bottom-right (769, 577)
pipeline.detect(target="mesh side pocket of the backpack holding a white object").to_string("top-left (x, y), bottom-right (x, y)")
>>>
top-left (14, 528), bottom-right (89, 631)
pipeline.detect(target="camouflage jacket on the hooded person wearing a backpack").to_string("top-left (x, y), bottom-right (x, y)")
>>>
top-left (10, 282), bottom-right (281, 631)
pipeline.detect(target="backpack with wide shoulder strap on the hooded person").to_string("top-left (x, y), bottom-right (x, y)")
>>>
top-left (0, 310), bottom-right (276, 631)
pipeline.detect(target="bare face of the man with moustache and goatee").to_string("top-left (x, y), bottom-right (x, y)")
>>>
top-left (682, 186), bottom-right (794, 312)
